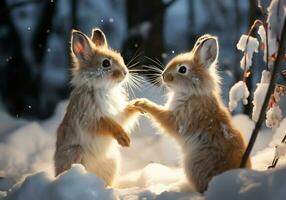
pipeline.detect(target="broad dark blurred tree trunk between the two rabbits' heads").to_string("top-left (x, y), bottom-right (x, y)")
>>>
top-left (123, 0), bottom-right (175, 63)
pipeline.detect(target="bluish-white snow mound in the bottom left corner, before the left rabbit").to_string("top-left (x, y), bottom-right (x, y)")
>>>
top-left (5, 164), bottom-right (119, 200)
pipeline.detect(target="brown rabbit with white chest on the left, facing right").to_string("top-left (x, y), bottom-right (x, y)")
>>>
top-left (54, 29), bottom-right (140, 185)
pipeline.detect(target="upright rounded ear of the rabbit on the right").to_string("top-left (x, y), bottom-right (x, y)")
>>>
top-left (193, 35), bottom-right (218, 68)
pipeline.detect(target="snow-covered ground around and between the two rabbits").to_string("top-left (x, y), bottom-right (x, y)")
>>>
top-left (0, 85), bottom-right (286, 200)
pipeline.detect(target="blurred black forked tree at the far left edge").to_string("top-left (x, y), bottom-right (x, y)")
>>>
top-left (0, 1), bottom-right (56, 118)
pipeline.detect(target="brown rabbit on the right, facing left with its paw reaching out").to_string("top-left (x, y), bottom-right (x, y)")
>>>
top-left (133, 35), bottom-right (251, 192)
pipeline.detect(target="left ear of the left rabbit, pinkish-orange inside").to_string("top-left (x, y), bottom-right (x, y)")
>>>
top-left (71, 30), bottom-right (92, 60)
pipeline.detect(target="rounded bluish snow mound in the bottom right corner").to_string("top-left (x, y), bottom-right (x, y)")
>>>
top-left (205, 168), bottom-right (286, 200)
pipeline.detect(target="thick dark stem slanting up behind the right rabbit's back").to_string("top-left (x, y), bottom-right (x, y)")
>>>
top-left (240, 20), bottom-right (286, 168)
